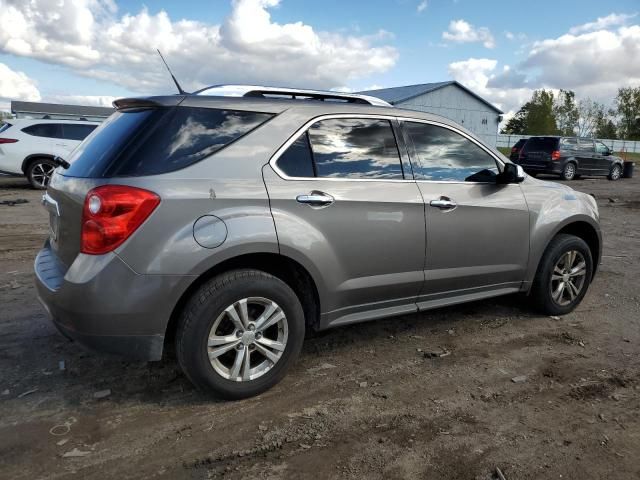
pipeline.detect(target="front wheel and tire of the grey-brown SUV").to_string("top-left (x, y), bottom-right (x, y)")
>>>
top-left (531, 234), bottom-right (593, 315)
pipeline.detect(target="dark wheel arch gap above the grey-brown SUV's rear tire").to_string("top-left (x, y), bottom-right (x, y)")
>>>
top-left (164, 252), bottom-right (321, 351)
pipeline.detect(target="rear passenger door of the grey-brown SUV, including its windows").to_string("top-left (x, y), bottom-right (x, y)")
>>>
top-left (264, 115), bottom-right (425, 325)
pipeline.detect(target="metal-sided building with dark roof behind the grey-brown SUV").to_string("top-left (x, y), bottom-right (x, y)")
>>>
top-left (358, 81), bottom-right (503, 147)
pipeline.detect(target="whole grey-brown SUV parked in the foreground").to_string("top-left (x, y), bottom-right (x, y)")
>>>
top-left (35, 87), bottom-right (601, 398)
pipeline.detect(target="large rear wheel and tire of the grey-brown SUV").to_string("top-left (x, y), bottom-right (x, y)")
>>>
top-left (176, 270), bottom-right (305, 400)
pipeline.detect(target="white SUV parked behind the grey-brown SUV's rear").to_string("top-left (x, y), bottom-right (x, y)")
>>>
top-left (0, 119), bottom-right (98, 189)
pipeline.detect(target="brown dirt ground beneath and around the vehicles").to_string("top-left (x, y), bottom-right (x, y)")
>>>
top-left (0, 175), bottom-right (640, 480)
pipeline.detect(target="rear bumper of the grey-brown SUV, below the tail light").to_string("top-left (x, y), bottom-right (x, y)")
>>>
top-left (34, 242), bottom-right (191, 360)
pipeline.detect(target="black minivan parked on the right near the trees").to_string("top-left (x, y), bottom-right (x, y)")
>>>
top-left (514, 136), bottom-right (624, 180)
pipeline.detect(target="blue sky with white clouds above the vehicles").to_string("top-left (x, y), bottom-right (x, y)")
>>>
top-left (0, 0), bottom-right (640, 118)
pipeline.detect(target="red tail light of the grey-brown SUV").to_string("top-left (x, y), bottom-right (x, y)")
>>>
top-left (80, 185), bottom-right (160, 255)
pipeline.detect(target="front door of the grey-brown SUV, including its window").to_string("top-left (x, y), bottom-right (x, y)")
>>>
top-left (402, 121), bottom-right (529, 307)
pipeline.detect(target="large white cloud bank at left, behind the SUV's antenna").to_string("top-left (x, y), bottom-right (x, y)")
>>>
top-left (0, 0), bottom-right (398, 93)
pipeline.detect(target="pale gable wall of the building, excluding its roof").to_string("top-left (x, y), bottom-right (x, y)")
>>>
top-left (395, 85), bottom-right (500, 147)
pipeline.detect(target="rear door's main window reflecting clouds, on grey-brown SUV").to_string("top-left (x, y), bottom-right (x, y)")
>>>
top-left (309, 118), bottom-right (403, 179)
